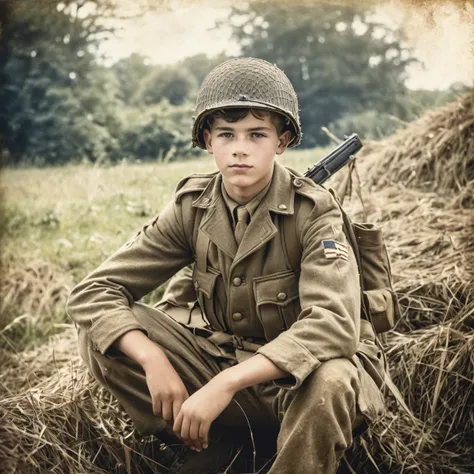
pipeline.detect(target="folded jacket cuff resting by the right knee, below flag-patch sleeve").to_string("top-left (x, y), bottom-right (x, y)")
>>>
top-left (257, 333), bottom-right (321, 390)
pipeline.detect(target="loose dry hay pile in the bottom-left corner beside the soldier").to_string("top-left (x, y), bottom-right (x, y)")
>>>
top-left (0, 329), bottom-right (174, 474)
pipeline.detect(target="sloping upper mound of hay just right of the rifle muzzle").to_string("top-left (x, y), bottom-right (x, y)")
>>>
top-left (361, 89), bottom-right (474, 208)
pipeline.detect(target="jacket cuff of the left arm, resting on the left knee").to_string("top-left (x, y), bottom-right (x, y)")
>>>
top-left (88, 311), bottom-right (148, 355)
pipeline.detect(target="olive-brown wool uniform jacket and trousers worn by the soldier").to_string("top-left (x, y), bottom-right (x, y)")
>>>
top-left (68, 163), bottom-right (383, 474)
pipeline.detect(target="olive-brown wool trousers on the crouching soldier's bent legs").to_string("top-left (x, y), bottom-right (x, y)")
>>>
top-left (79, 304), bottom-right (362, 474)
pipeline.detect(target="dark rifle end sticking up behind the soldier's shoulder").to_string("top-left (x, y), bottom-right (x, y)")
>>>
top-left (304, 133), bottom-right (363, 184)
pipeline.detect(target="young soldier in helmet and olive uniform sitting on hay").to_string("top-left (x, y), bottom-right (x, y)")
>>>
top-left (67, 58), bottom-right (383, 474)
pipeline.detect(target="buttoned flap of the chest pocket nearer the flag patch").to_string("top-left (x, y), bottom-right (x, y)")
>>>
top-left (253, 271), bottom-right (299, 306)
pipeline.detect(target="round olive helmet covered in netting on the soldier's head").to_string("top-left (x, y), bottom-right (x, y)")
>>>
top-left (192, 58), bottom-right (302, 149)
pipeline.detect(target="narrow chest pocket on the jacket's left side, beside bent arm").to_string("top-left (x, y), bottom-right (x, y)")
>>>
top-left (193, 265), bottom-right (224, 330)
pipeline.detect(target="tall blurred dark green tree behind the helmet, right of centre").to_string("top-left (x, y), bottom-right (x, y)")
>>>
top-left (231, 1), bottom-right (412, 147)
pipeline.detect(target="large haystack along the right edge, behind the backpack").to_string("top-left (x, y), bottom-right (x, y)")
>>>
top-left (338, 90), bottom-right (474, 473)
